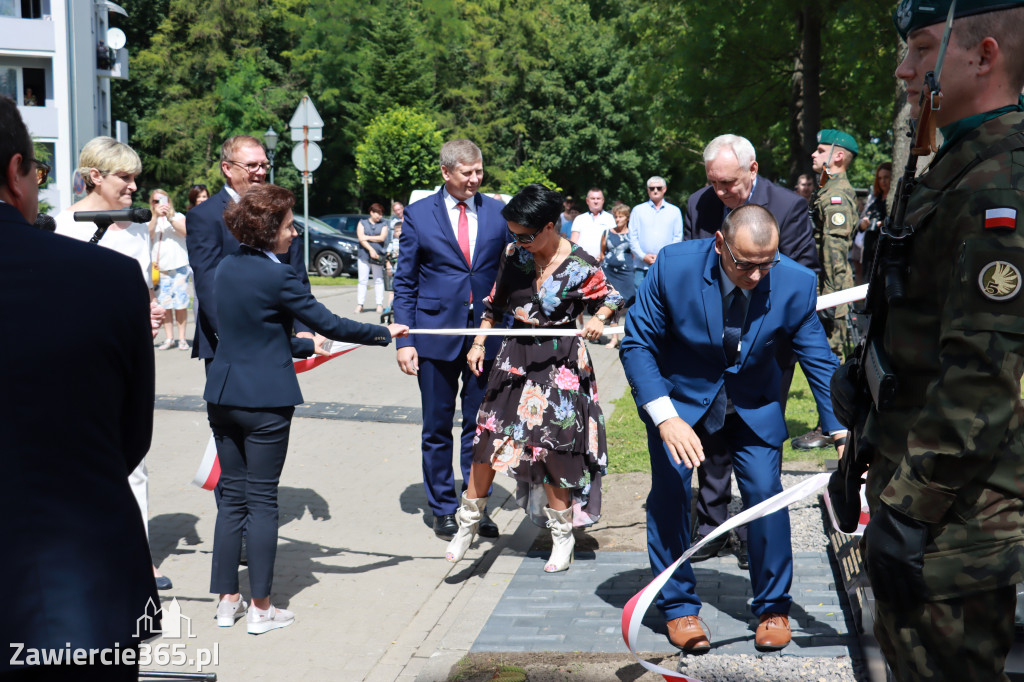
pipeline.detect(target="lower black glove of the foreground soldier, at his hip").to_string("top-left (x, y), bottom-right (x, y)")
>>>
top-left (864, 504), bottom-right (928, 611)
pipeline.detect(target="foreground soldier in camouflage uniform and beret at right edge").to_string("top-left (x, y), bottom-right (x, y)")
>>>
top-left (862, 0), bottom-right (1024, 681)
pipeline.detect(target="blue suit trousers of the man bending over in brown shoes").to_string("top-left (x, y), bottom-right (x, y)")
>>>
top-left (639, 409), bottom-right (793, 621)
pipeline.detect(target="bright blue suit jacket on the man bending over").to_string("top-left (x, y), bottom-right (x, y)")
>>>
top-left (621, 240), bottom-right (841, 446)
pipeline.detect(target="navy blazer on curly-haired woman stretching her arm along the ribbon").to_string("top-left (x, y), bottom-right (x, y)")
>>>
top-left (203, 246), bottom-right (391, 408)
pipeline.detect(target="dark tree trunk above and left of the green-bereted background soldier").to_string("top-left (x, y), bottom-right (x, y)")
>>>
top-left (790, 1), bottom-right (823, 185)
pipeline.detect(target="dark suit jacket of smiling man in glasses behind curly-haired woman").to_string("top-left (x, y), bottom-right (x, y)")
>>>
top-left (185, 189), bottom-right (309, 357)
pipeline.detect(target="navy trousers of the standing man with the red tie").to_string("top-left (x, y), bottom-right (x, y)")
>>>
top-left (417, 350), bottom-right (494, 516)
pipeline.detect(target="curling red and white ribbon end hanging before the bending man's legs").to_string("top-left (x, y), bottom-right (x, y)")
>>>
top-left (623, 473), bottom-right (830, 682)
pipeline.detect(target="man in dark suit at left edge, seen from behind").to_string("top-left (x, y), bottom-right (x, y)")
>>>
top-left (0, 96), bottom-right (160, 682)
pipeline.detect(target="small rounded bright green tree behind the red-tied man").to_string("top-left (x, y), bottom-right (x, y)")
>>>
top-left (355, 106), bottom-right (443, 203)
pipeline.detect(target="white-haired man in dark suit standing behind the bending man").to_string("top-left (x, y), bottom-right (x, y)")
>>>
top-left (684, 135), bottom-right (820, 568)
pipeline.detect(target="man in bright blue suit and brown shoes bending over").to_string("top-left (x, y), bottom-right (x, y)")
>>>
top-left (621, 204), bottom-right (845, 653)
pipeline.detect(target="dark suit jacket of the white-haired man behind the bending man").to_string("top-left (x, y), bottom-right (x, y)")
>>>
top-left (683, 175), bottom-right (821, 272)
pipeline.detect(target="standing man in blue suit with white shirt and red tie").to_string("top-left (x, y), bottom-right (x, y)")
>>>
top-left (394, 139), bottom-right (508, 540)
